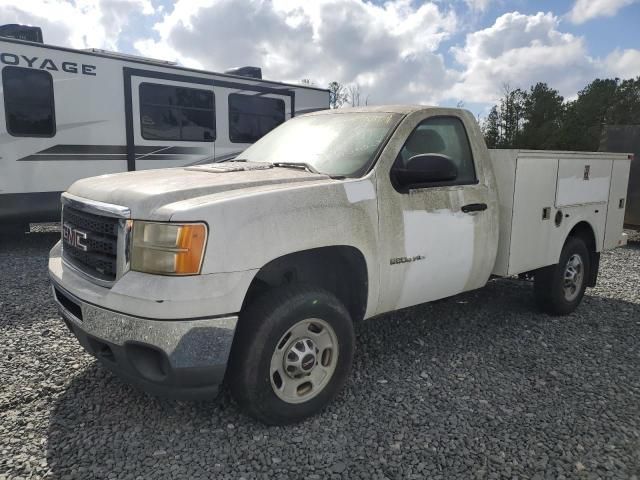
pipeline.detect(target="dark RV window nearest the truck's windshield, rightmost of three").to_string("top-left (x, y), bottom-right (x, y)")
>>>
top-left (229, 93), bottom-right (284, 143)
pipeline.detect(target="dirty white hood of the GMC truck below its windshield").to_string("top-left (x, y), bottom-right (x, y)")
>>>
top-left (68, 162), bottom-right (332, 219)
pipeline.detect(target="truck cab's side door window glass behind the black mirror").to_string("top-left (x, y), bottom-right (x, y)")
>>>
top-left (396, 117), bottom-right (477, 185)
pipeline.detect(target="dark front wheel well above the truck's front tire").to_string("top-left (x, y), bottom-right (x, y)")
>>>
top-left (242, 246), bottom-right (369, 321)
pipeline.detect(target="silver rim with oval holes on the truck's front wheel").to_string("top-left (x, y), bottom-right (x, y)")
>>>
top-left (269, 318), bottom-right (338, 403)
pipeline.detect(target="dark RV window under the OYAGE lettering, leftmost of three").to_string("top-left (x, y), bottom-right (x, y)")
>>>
top-left (2, 67), bottom-right (56, 137)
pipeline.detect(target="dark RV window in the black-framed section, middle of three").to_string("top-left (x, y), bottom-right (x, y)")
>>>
top-left (140, 83), bottom-right (216, 142)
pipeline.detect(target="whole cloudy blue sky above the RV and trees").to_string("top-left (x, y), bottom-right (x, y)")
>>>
top-left (0, 0), bottom-right (640, 114)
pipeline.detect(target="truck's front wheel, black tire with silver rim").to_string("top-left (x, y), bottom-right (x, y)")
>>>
top-left (227, 285), bottom-right (354, 425)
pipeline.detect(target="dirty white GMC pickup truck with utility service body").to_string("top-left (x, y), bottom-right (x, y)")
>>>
top-left (49, 106), bottom-right (630, 424)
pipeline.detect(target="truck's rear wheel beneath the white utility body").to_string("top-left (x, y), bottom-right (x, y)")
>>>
top-left (534, 237), bottom-right (591, 315)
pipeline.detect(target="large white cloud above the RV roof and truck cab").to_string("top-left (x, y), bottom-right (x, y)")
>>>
top-left (135, 0), bottom-right (457, 103)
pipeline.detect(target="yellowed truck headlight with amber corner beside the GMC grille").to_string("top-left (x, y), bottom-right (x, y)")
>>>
top-left (131, 220), bottom-right (207, 275)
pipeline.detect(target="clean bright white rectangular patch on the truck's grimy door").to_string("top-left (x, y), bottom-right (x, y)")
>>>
top-left (397, 210), bottom-right (474, 308)
